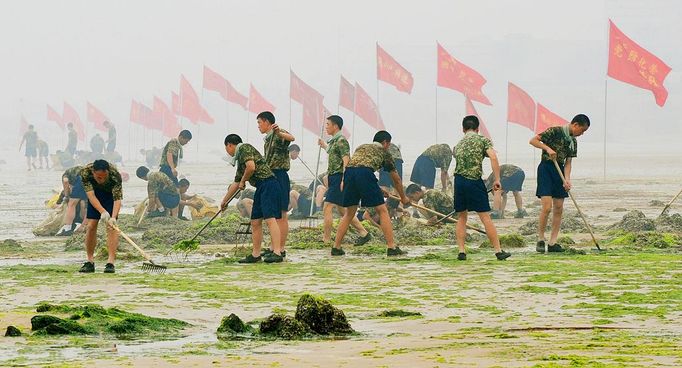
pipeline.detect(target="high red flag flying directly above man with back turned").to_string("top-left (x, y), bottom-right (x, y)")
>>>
top-left (438, 44), bottom-right (492, 105)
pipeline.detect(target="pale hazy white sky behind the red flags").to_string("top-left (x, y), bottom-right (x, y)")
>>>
top-left (0, 0), bottom-right (682, 167)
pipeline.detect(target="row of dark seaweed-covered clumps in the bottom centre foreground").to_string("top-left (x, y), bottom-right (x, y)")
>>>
top-left (217, 294), bottom-right (355, 340)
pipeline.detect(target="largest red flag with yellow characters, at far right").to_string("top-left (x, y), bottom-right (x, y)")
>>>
top-left (607, 20), bottom-right (671, 106)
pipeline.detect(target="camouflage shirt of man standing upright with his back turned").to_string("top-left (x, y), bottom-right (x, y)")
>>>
top-left (455, 132), bottom-right (493, 180)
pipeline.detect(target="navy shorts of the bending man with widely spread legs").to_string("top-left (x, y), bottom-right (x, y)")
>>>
top-left (343, 167), bottom-right (384, 207)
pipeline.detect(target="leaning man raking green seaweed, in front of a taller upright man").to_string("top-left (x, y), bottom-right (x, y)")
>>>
top-left (220, 134), bottom-right (285, 263)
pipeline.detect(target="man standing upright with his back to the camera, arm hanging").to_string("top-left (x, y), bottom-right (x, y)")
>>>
top-left (454, 115), bottom-right (511, 261)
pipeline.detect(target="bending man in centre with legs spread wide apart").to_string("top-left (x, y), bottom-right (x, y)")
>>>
top-left (332, 130), bottom-right (410, 256)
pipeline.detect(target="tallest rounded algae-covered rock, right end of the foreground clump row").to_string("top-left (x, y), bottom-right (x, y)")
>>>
top-left (296, 294), bottom-right (354, 335)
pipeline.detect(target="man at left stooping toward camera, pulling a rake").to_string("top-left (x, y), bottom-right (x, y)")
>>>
top-left (79, 160), bottom-right (123, 273)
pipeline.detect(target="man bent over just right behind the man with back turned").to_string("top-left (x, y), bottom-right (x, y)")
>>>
top-left (485, 164), bottom-right (528, 219)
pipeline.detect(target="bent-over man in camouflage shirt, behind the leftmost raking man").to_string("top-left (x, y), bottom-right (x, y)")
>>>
top-left (136, 166), bottom-right (180, 217)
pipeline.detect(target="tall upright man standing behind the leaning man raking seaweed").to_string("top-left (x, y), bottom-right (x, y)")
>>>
top-left (256, 111), bottom-right (296, 254)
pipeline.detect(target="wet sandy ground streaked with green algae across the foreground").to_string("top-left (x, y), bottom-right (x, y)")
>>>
top-left (0, 176), bottom-right (682, 367)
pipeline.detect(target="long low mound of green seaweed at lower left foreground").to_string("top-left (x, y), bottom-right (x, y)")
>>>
top-left (31, 304), bottom-right (191, 339)
